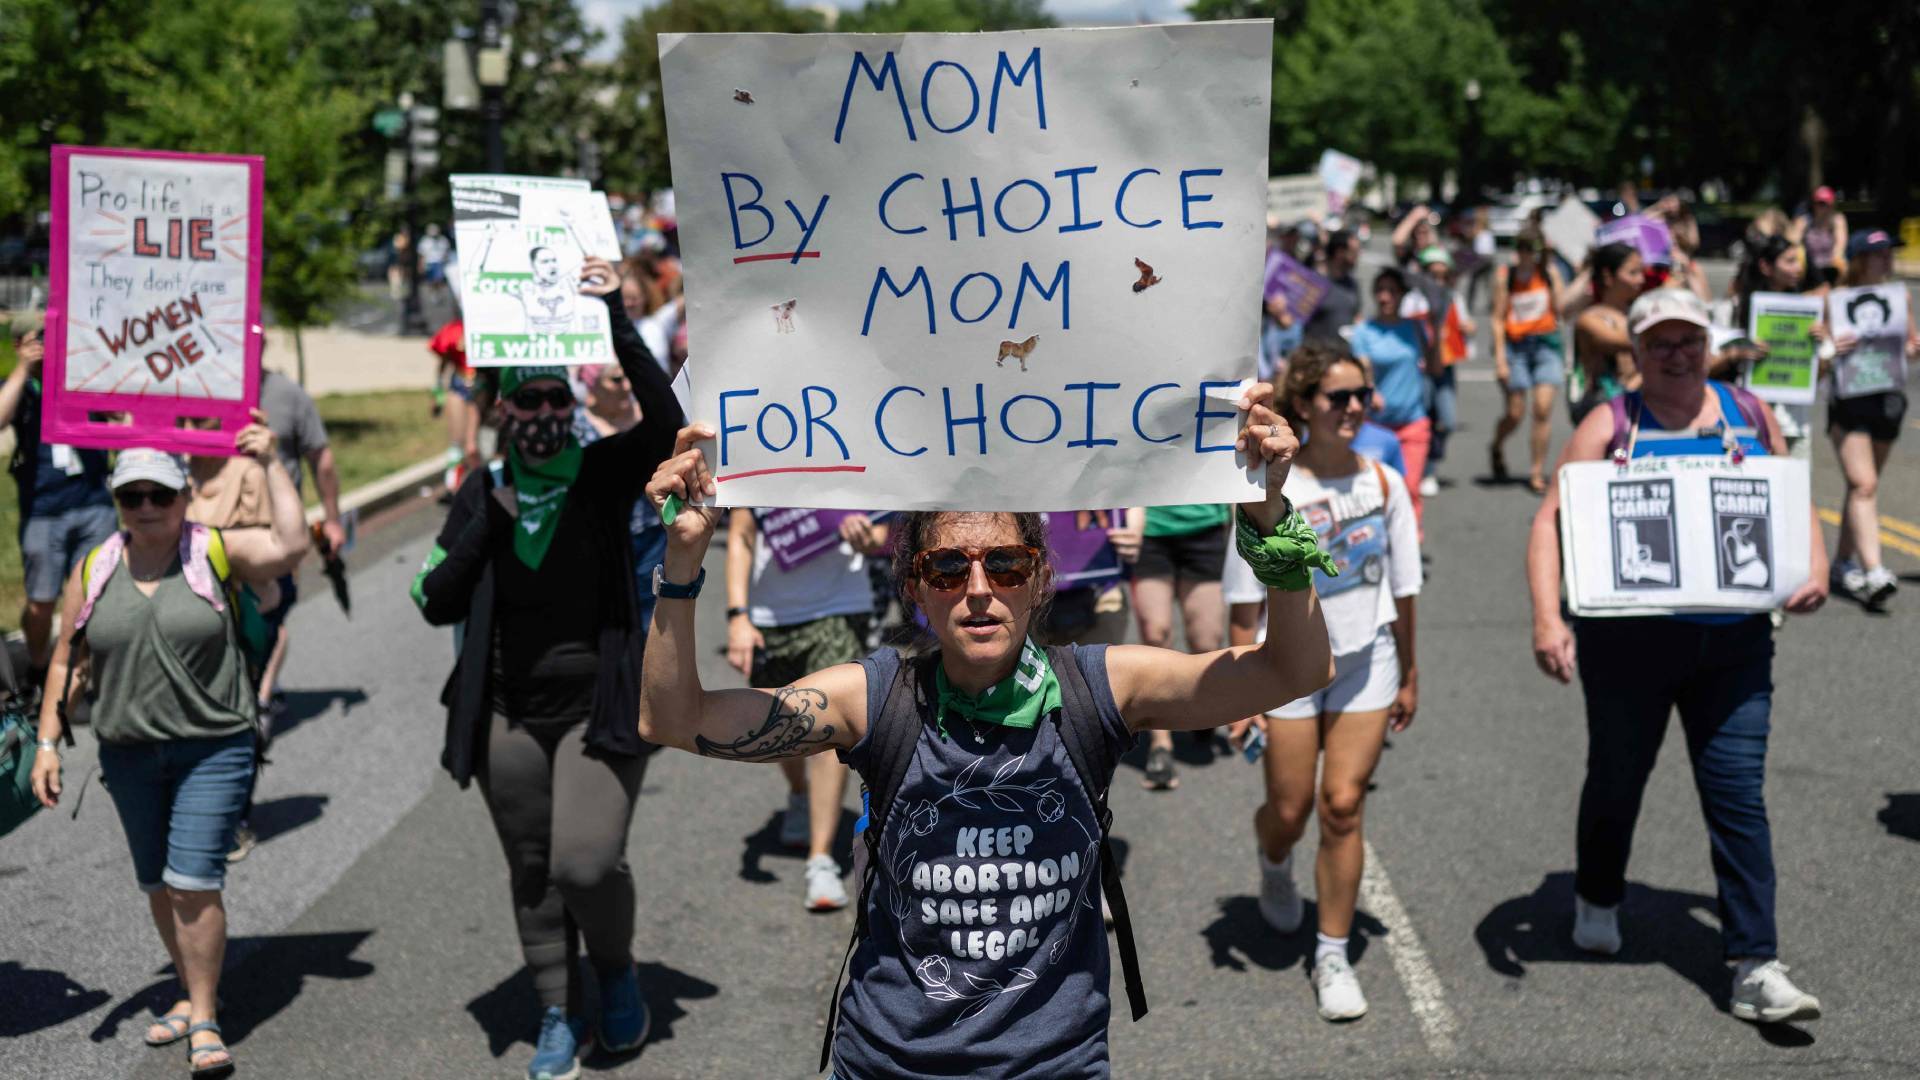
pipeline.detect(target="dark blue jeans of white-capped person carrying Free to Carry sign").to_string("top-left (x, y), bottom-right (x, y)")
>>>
top-left (1574, 615), bottom-right (1780, 957)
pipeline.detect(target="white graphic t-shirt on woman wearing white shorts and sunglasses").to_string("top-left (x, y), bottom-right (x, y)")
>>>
top-left (1221, 457), bottom-right (1423, 655)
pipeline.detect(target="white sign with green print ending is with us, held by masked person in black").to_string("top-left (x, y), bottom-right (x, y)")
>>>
top-left (449, 175), bottom-right (620, 367)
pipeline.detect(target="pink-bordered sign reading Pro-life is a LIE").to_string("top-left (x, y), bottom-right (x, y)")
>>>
top-left (40, 146), bottom-right (265, 454)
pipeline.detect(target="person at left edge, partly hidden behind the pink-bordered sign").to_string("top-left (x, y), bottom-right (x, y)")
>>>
top-left (0, 311), bottom-right (115, 690)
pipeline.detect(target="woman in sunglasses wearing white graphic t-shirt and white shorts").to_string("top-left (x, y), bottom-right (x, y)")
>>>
top-left (1225, 346), bottom-right (1421, 1020)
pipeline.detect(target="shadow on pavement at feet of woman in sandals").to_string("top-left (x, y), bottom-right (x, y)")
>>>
top-left (88, 930), bottom-right (372, 1045)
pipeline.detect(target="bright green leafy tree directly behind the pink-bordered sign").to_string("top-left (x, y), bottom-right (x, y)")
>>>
top-left (108, 0), bottom-right (369, 378)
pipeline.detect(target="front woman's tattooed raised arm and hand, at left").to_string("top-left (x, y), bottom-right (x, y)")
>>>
top-left (639, 425), bottom-right (866, 761)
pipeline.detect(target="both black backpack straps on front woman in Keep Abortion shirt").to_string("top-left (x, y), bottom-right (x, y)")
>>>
top-left (820, 646), bottom-right (1146, 1070)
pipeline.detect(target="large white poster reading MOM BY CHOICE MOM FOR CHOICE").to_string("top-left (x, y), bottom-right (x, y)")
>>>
top-left (660, 23), bottom-right (1273, 509)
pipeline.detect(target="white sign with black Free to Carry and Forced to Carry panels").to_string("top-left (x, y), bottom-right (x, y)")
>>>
top-left (1559, 455), bottom-right (1812, 615)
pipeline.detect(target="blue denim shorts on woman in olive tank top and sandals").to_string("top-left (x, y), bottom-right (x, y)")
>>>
top-left (100, 732), bottom-right (253, 892)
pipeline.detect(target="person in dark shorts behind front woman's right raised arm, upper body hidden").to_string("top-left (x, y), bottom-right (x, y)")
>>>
top-left (1133, 503), bottom-right (1231, 780)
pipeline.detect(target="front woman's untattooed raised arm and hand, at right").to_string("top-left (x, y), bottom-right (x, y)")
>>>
top-left (1106, 382), bottom-right (1332, 730)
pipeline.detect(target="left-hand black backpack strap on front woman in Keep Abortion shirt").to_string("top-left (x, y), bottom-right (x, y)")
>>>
top-left (820, 641), bottom-right (939, 1072)
